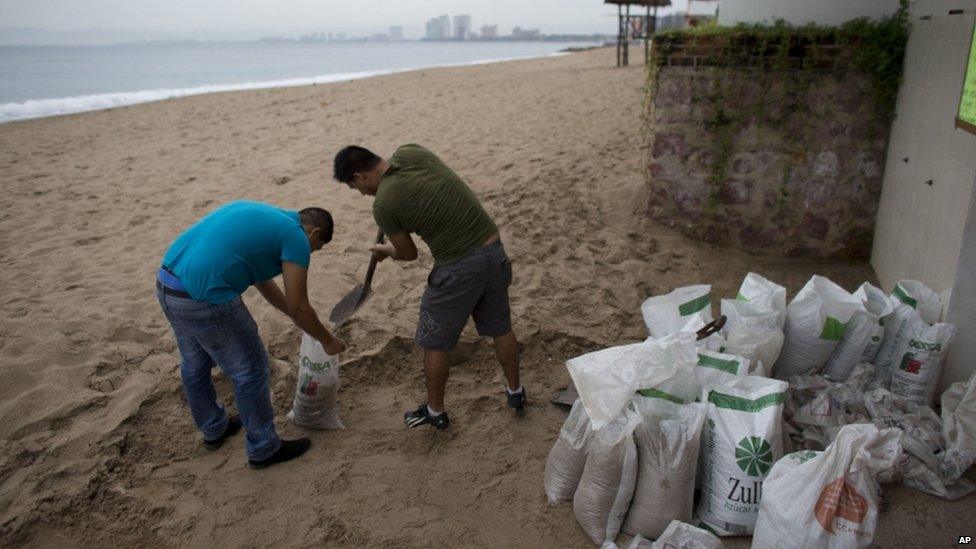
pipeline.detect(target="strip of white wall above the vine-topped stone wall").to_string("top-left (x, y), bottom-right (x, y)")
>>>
top-left (718, 0), bottom-right (898, 25)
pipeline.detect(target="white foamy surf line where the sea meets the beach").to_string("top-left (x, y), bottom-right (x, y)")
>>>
top-left (0, 46), bottom-right (588, 125)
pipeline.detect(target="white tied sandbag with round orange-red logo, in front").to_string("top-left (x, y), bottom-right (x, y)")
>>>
top-left (752, 424), bottom-right (901, 549)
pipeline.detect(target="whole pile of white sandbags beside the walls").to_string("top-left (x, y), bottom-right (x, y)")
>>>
top-left (545, 273), bottom-right (976, 548)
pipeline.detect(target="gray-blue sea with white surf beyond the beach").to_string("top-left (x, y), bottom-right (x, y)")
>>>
top-left (0, 42), bottom-right (592, 123)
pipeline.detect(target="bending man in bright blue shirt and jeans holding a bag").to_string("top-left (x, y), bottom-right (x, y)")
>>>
top-left (156, 201), bottom-right (345, 469)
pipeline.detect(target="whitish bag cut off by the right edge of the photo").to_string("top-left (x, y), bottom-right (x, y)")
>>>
top-left (940, 374), bottom-right (976, 481)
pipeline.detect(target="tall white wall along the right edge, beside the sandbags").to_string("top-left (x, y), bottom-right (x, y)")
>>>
top-left (871, 0), bottom-right (976, 385)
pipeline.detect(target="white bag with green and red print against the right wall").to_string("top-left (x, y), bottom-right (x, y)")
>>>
top-left (891, 317), bottom-right (956, 406)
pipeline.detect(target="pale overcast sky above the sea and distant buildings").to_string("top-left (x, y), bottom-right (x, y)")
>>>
top-left (0, 0), bottom-right (714, 37)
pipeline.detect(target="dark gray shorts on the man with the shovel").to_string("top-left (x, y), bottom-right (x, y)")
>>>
top-left (414, 240), bottom-right (512, 351)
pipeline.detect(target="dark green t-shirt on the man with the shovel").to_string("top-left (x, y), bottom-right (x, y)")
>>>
top-left (373, 144), bottom-right (498, 265)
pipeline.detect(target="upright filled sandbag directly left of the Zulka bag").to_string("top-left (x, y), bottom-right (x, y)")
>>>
top-left (623, 396), bottom-right (705, 538)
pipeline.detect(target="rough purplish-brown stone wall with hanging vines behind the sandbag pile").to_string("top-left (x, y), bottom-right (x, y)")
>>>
top-left (646, 49), bottom-right (888, 260)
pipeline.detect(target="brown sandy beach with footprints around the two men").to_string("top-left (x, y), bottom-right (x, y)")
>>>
top-left (0, 50), bottom-right (976, 547)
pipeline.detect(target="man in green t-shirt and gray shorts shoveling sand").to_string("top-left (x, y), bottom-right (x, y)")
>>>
top-left (334, 144), bottom-right (525, 429)
